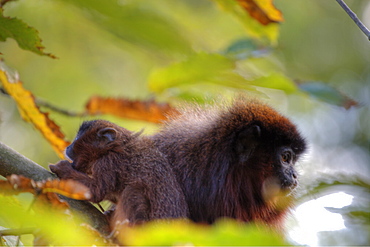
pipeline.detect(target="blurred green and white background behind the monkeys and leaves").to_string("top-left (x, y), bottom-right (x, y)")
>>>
top-left (0, 0), bottom-right (370, 245)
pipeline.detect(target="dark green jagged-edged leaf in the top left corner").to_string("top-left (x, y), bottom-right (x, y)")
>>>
top-left (0, 8), bottom-right (55, 58)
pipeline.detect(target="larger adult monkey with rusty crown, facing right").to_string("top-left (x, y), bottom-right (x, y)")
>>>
top-left (151, 98), bottom-right (307, 229)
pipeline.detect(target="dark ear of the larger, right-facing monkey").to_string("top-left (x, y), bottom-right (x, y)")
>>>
top-left (236, 125), bottom-right (261, 163)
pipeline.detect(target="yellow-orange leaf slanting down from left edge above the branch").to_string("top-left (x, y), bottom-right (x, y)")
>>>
top-left (0, 61), bottom-right (69, 159)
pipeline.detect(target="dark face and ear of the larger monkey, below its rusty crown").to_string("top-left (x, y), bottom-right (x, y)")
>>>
top-left (235, 124), bottom-right (305, 192)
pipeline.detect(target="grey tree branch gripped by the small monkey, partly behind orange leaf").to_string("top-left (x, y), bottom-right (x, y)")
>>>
top-left (0, 142), bottom-right (109, 235)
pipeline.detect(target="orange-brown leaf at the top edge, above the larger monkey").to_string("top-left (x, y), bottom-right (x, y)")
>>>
top-left (237, 0), bottom-right (284, 25)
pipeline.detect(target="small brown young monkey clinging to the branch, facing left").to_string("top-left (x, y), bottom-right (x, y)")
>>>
top-left (49, 120), bottom-right (188, 229)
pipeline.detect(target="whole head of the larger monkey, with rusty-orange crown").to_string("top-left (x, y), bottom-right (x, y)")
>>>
top-left (228, 101), bottom-right (306, 197)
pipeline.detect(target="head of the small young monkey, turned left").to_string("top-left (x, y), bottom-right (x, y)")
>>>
top-left (66, 120), bottom-right (132, 174)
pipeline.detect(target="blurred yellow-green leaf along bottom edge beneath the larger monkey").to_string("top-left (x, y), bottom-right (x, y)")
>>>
top-left (118, 220), bottom-right (286, 246)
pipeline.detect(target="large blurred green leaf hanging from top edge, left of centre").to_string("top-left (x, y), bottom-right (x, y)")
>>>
top-left (62, 0), bottom-right (191, 53)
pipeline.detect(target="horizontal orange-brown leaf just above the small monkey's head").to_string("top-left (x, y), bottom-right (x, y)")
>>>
top-left (86, 96), bottom-right (178, 123)
